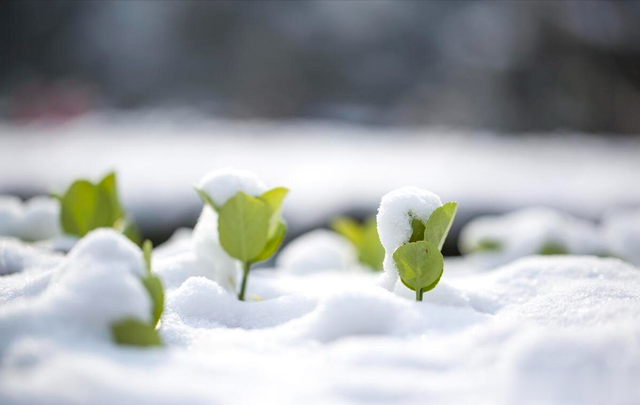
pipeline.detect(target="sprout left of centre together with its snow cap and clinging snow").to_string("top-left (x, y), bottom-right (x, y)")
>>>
top-left (195, 169), bottom-right (289, 300)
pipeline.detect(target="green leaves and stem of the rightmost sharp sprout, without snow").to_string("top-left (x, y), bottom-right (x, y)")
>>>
top-left (393, 202), bottom-right (458, 301)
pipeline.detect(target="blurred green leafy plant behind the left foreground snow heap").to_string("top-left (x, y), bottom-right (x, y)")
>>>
top-left (54, 172), bottom-right (140, 244)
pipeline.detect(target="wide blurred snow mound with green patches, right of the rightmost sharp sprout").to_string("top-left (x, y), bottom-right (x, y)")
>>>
top-left (459, 207), bottom-right (605, 266)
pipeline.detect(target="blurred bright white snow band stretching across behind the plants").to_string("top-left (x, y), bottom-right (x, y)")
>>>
top-left (0, 113), bottom-right (640, 233)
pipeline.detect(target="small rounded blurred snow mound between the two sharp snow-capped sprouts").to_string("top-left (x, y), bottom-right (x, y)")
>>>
top-left (276, 229), bottom-right (358, 275)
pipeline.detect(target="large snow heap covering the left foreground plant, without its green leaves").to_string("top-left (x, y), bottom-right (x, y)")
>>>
top-left (0, 229), bottom-right (151, 350)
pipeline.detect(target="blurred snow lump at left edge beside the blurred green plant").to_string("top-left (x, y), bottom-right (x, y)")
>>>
top-left (0, 196), bottom-right (62, 241)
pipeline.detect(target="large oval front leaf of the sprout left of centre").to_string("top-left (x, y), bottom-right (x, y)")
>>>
top-left (218, 191), bottom-right (271, 263)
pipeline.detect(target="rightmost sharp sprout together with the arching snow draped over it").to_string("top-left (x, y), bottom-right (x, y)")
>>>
top-left (377, 187), bottom-right (457, 300)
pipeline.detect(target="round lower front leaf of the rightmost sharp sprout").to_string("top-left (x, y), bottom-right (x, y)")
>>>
top-left (393, 241), bottom-right (444, 291)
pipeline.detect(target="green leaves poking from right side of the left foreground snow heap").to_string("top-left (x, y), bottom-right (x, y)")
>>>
top-left (111, 240), bottom-right (164, 346)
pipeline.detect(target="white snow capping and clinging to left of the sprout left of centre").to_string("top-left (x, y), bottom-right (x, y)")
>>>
top-left (193, 169), bottom-right (267, 292)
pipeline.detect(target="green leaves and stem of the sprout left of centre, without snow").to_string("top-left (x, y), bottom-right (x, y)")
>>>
top-left (196, 187), bottom-right (289, 301)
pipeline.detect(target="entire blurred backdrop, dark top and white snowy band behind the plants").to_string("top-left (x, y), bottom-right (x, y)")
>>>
top-left (0, 0), bottom-right (640, 254)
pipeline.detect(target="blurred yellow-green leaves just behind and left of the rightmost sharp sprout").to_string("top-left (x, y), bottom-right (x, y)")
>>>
top-left (331, 217), bottom-right (384, 271)
